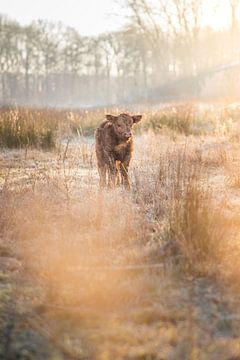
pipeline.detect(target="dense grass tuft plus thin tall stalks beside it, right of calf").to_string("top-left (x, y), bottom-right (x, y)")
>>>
top-left (135, 143), bottom-right (229, 275)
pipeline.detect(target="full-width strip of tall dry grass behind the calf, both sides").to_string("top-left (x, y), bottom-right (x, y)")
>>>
top-left (0, 103), bottom-right (240, 149)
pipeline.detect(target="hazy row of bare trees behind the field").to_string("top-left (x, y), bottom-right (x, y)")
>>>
top-left (0, 0), bottom-right (240, 107)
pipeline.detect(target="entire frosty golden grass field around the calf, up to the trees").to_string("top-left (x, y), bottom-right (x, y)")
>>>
top-left (0, 103), bottom-right (240, 360)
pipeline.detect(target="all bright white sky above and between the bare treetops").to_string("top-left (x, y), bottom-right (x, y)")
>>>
top-left (0, 0), bottom-right (240, 35)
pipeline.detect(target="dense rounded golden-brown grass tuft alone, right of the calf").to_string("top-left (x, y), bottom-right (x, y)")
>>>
top-left (165, 180), bottom-right (225, 275)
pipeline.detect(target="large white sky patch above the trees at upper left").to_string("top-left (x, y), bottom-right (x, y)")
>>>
top-left (0, 0), bottom-right (124, 35)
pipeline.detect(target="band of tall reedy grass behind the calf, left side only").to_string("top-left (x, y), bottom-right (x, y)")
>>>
top-left (0, 107), bottom-right (105, 150)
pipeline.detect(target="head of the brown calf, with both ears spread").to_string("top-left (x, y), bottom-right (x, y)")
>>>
top-left (106, 114), bottom-right (142, 141)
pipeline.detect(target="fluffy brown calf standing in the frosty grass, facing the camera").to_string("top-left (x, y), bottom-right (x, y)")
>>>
top-left (95, 114), bottom-right (142, 187)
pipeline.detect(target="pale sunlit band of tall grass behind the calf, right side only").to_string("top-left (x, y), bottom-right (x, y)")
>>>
top-left (139, 103), bottom-right (240, 136)
